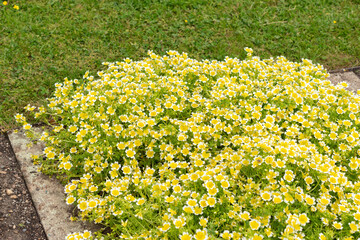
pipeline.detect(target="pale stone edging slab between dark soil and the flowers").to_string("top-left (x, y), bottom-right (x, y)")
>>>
top-left (8, 128), bottom-right (99, 240)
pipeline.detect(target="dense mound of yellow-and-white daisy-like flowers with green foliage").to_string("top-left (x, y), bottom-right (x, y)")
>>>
top-left (16, 48), bottom-right (360, 240)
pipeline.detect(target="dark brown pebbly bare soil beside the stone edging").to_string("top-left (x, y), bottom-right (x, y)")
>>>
top-left (0, 133), bottom-right (47, 240)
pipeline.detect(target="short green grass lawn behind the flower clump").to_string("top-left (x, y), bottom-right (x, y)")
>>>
top-left (0, 0), bottom-right (360, 130)
